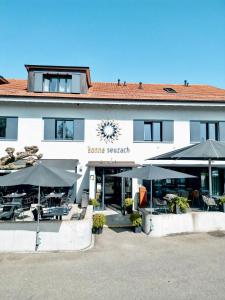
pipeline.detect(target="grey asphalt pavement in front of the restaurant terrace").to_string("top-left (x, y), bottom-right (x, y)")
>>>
top-left (0, 228), bottom-right (225, 300)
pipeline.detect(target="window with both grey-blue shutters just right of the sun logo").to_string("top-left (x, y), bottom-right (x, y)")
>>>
top-left (133, 120), bottom-right (174, 143)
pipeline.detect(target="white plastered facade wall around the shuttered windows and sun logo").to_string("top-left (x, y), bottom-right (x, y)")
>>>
top-left (0, 98), bottom-right (225, 201)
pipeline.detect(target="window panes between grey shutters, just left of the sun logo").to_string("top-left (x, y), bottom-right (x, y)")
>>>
top-left (55, 120), bottom-right (74, 140)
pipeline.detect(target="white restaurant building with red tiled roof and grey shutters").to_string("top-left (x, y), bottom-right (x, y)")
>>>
top-left (0, 65), bottom-right (225, 211)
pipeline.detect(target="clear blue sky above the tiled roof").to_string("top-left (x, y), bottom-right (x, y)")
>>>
top-left (0, 0), bottom-right (225, 88)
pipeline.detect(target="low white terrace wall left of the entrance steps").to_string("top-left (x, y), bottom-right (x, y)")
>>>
top-left (0, 206), bottom-right (93, 252)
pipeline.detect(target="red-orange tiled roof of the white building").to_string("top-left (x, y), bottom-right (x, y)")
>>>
top-left (0, 79), bottom-right (225, 102)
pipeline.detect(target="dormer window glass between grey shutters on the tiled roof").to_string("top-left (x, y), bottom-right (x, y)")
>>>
top-left (43, 74), bottom-right (72, 93)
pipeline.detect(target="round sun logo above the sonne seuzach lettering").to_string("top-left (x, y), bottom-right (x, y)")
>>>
top-left (97, 121), bottom-right (120, 143)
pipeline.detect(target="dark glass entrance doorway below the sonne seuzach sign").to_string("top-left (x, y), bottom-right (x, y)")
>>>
top-left (96, 168), bottom-right (132, 210)
